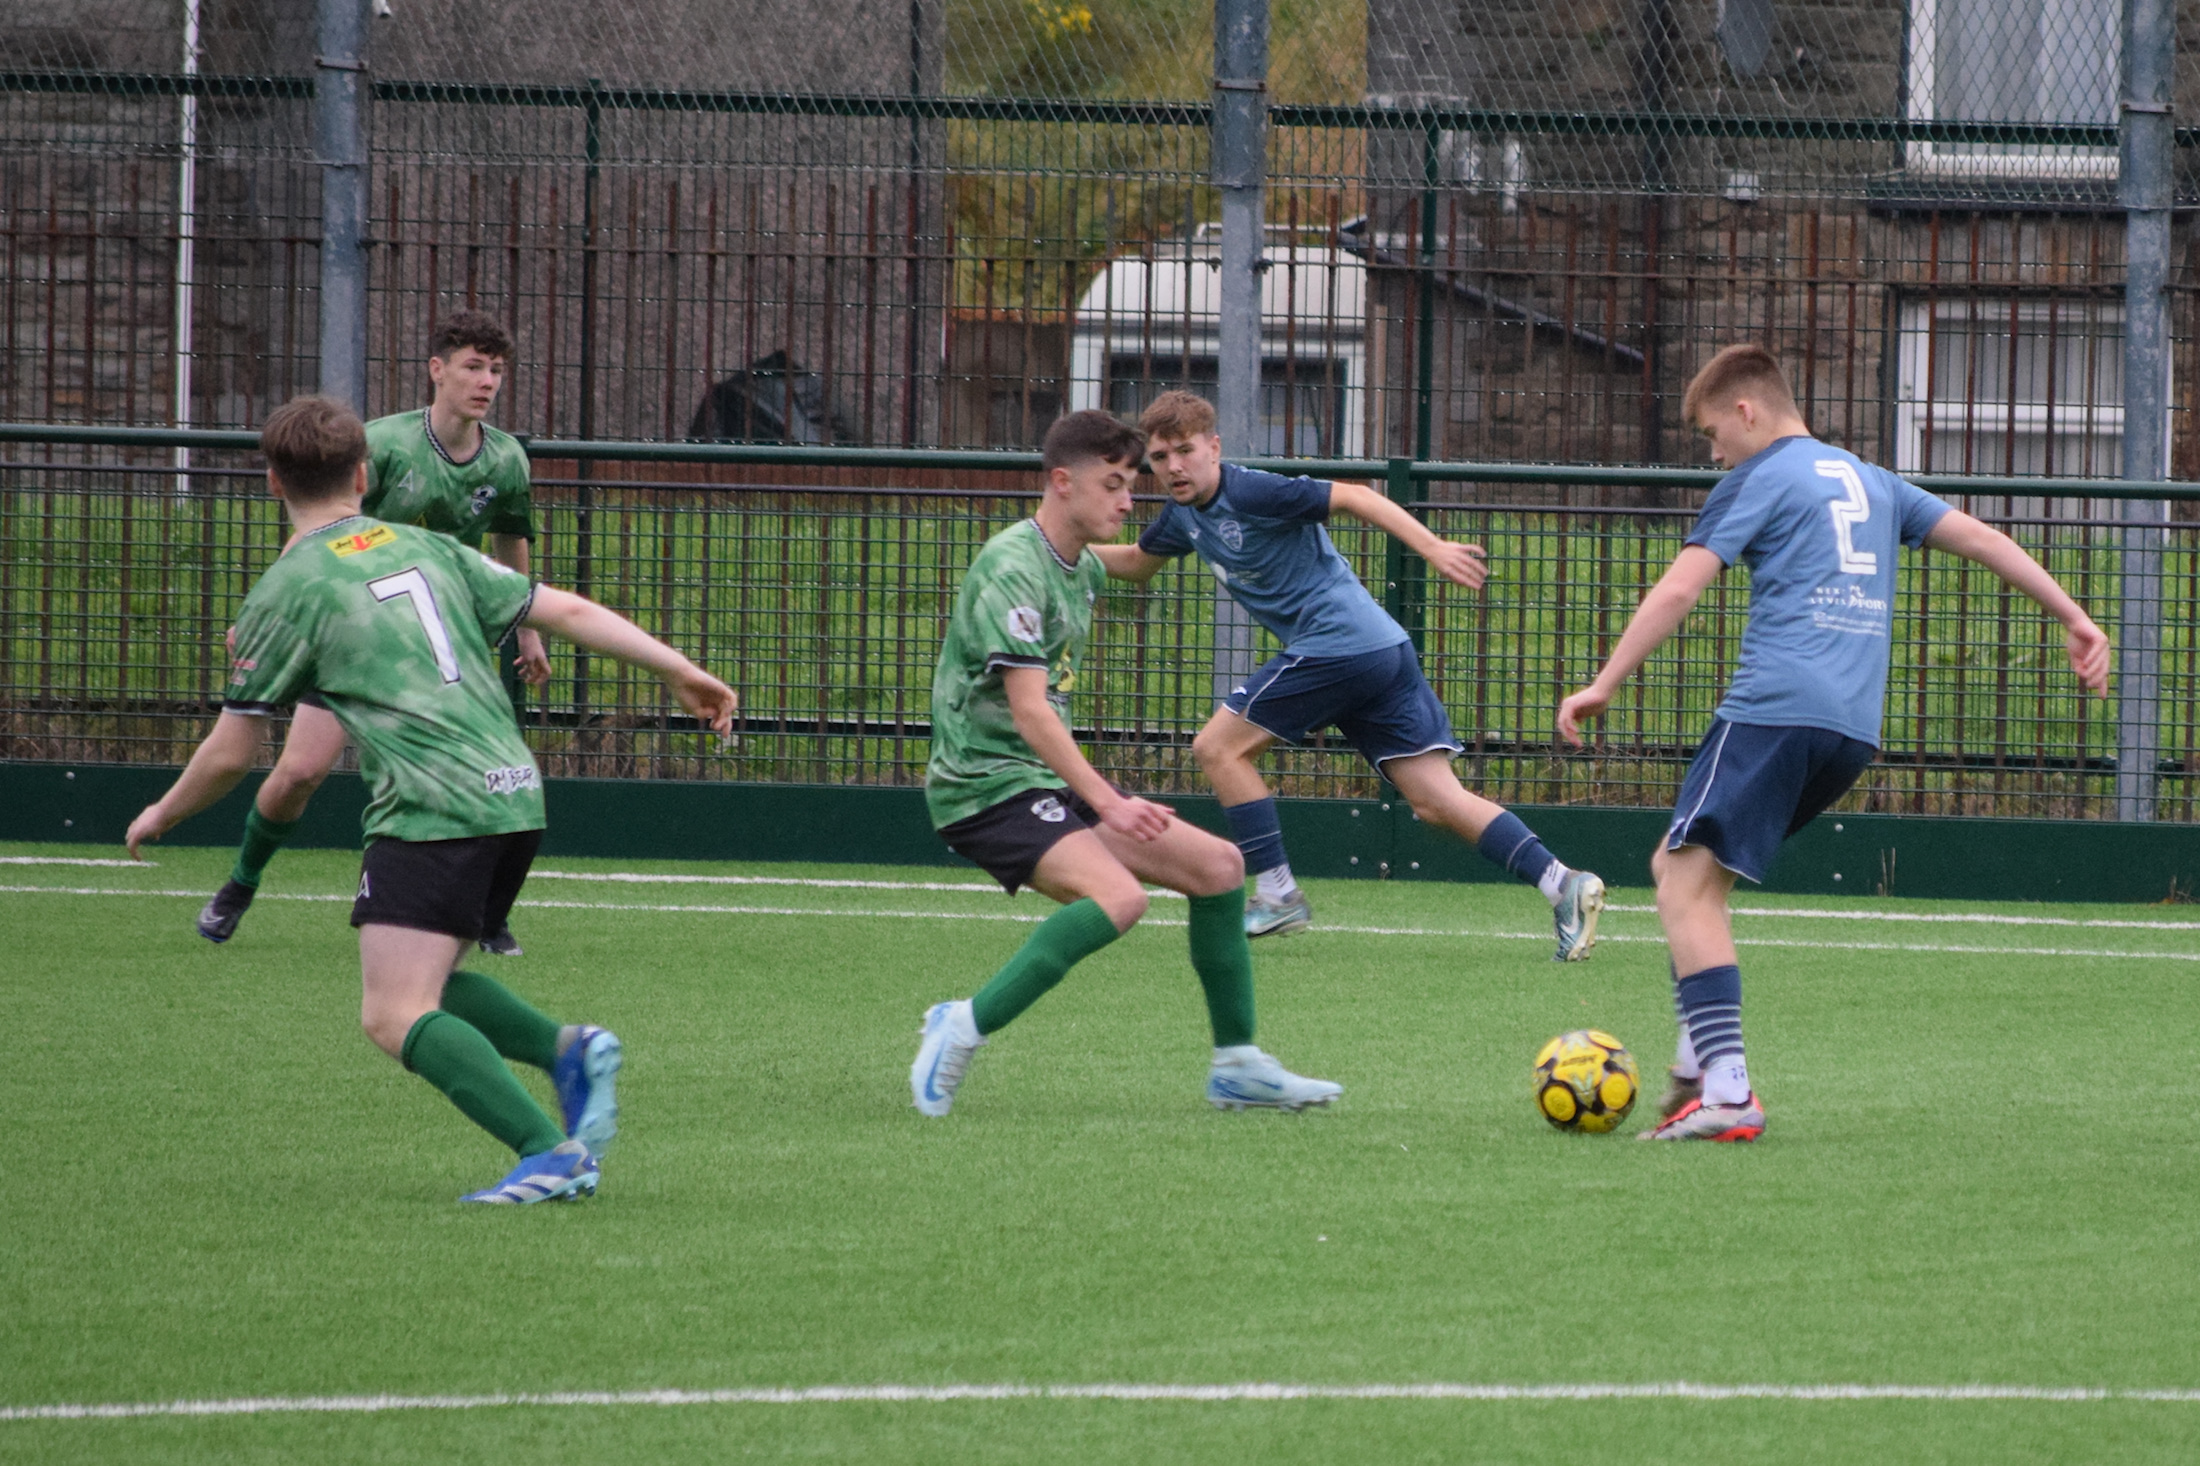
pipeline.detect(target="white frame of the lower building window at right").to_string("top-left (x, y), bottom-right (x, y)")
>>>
top-left (1894, 295), bottom-right (2123, 478)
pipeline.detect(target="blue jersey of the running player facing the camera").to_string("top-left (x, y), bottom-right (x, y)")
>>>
top-left (1137, 462), bottom-right (1408, 656)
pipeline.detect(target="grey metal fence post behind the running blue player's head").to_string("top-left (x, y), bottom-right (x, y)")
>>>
top-left (1208, 0), bottom-right (1267, 702)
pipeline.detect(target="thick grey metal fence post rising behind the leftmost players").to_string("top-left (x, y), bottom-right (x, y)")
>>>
top-left (312, 0), bottom-right (367, 412)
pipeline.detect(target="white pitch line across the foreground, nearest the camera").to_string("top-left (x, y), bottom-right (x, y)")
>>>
top-left (0, 1380), bottom-right (2200, 1420)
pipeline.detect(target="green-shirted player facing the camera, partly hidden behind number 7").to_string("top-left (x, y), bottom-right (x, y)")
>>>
top-left (198, 310), bottom-right (550, 958)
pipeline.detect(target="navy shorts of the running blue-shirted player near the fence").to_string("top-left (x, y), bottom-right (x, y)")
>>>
top-left (1223, 641), bottom-right (1461, 770)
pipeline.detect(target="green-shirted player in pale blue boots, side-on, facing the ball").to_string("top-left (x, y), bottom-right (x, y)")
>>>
top-left (909, 412), bottom-right (1342, 1116)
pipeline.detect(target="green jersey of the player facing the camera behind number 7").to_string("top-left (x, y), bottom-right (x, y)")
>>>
top-left (361, 407), bottom-right (535, 550)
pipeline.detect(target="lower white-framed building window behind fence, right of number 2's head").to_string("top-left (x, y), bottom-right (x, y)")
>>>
top-left (1894, 295), bottom-right (2123, 478)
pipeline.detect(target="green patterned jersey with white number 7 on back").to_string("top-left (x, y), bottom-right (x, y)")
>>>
top-left (222, 517), bottom-right (543, 841)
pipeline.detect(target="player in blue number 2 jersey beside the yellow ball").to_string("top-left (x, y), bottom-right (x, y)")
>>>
top-left (1558, 346), bottom-right (2108, 1140)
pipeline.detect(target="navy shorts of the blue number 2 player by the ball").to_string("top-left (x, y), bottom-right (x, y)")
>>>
top-left (1665, 718), bottom-right (1879, 883)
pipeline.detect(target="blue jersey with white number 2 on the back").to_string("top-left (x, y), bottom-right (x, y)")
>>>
top-left (1687, 438), bottom-right (1949, 746)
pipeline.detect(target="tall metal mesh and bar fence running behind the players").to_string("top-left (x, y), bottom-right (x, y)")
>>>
top-left (0, 0), bottom-right (2200, 819)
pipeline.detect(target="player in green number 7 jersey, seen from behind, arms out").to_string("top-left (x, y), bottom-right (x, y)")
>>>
top-left (125, 396), bottom-right (735, 1202)
